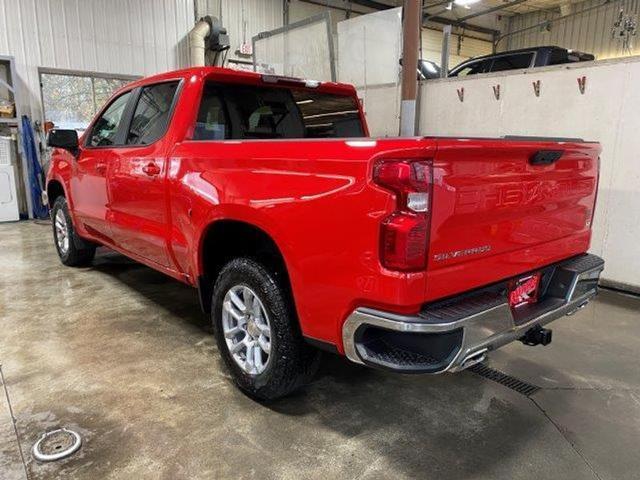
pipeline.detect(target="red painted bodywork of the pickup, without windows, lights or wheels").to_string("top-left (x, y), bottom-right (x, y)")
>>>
top-left (48, 68), bottom-right (600, 350)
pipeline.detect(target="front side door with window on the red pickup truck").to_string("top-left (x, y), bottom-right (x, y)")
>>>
top-left (70, 88), bottom-right (131, 242)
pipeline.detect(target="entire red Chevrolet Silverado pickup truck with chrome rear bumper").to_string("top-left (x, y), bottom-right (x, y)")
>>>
top-left (46, 67), bottom-right (604, 399)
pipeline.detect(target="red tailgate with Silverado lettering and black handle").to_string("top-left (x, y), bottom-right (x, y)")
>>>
top-left (427, 139), bottom-right (600, 298)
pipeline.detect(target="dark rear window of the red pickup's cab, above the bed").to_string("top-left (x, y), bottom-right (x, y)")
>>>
top-left (193, 83), bottom-right (364, 140)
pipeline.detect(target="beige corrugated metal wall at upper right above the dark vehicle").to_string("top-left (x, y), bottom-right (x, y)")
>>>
top-left (499, 0), bottom-right (640, 59)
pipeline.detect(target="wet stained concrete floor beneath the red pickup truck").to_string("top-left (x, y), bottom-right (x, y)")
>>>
top-left (0, 222), bottom-right (640, 480)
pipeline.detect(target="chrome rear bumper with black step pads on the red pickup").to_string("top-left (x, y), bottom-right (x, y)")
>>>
top-left (342, 254), bottom-right (604, 373)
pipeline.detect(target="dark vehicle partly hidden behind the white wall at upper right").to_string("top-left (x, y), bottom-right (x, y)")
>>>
top-left (449, 47), bottom-right (596, 77)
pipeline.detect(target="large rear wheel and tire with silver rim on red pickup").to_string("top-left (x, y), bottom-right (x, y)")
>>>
top-left (211, 258), bottom-right (320, 400)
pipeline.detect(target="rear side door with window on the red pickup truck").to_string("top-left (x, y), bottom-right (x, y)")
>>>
top-left (109, 81), bottom-right (180, 267)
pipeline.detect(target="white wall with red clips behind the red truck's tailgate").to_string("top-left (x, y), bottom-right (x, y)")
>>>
top-left (420, 57), bottom-right (640, 289)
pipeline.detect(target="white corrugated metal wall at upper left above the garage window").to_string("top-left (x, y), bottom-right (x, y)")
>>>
top-left (0, 0), bottom-right (194, 118)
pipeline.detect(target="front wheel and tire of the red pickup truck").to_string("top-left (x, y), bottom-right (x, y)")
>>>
top-left (51, 197), bottom-right (96, 267)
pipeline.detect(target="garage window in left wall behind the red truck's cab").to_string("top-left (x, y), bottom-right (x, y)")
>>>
top-left (40, 70), bottom-right (134, 131)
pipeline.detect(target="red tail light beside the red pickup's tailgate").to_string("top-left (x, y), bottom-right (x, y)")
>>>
top-left (373, 160), bottom-right (432, 272)
